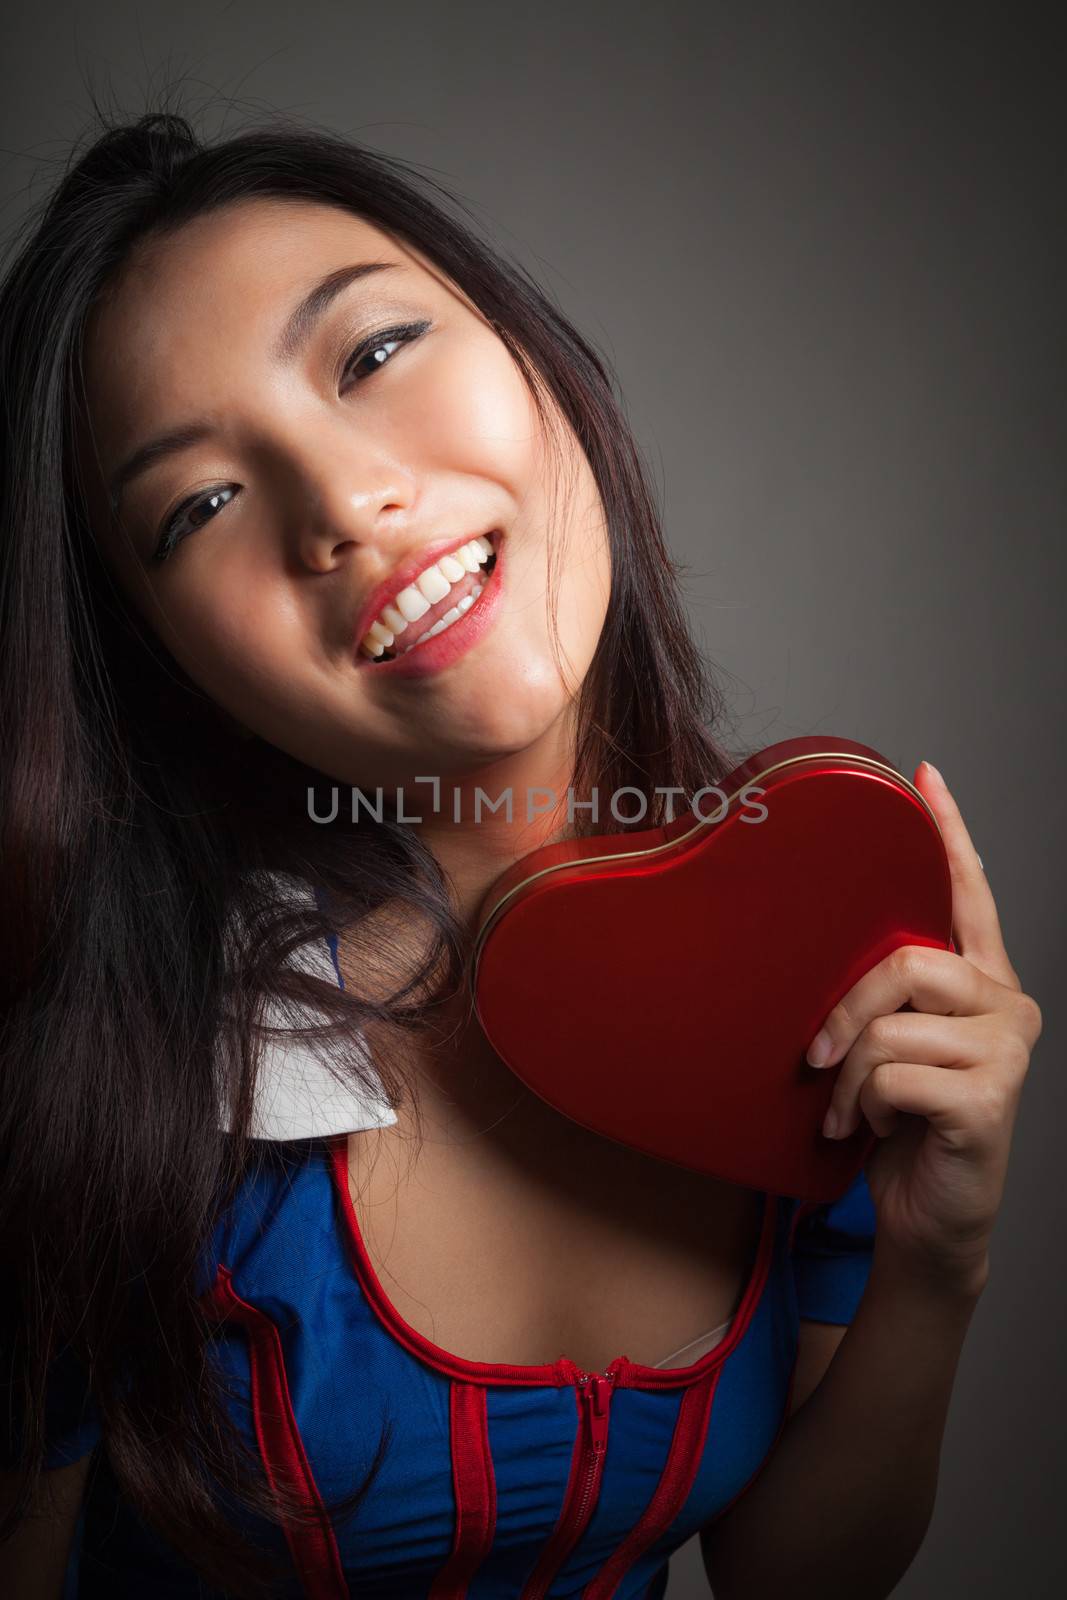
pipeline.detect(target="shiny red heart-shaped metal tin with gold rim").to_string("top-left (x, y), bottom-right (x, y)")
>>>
top-left (470, 736), bottom-right (952, 1202)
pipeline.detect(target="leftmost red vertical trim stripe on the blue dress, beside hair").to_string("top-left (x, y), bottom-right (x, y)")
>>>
top-left (205, 1262), bottom-right (349, 1600)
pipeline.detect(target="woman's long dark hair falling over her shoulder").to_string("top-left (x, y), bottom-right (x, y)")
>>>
top-left (0, 93), bottom-right (748, 1595)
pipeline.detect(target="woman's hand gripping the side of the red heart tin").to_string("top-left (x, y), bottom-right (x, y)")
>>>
top-left (809, 763), bottom-right (1041, 1286)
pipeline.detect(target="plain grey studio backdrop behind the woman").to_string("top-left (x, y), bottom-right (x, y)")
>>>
top-left (0, 0), bottom-right (1067, 1600)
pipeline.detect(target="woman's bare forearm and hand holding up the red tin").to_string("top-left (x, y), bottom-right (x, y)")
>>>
top-left (701, 762), bottom-right (1041, 1600)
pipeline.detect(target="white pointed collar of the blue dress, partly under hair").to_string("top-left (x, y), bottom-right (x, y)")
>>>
top-left (219, 875), bottom-right (397, 1139)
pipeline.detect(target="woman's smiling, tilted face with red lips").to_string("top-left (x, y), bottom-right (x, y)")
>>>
top-left (83, 200), bottom-right (611, 797)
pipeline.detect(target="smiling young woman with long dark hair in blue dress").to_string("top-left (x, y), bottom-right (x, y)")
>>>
top-left (0, 114), bottom-right (1040, 1600)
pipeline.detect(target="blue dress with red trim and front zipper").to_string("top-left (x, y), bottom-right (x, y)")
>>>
top-left (8, 921), bottom-right (875, 1600)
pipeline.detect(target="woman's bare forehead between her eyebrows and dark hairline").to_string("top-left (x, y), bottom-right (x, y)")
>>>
top-left (85, 198), bottom-right (445, 440)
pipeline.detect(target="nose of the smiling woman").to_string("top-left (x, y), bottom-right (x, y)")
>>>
top-left (296, 435), bottom-right (416, 573)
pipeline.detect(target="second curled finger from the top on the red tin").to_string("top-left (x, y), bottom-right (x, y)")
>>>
top-left (824, 1011), bottom-right (990, 1139)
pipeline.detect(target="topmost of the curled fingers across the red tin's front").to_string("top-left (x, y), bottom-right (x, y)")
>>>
top-left (808, 944), bottom-right (1008, 1067)
